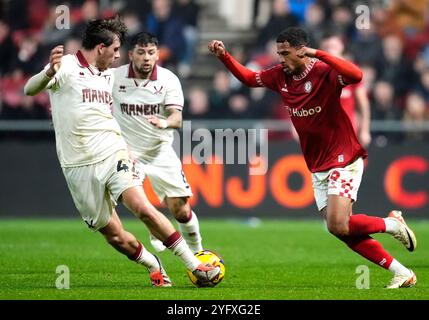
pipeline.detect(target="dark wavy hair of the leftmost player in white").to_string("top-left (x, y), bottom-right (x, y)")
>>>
top-left (82, 17), bottom-right (127, 50)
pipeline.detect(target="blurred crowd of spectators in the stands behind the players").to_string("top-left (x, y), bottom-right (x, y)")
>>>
top-left (0, 0), bottom-right (429, 140)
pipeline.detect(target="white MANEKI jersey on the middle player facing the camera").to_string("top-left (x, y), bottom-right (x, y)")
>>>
top-left (113, 64), bottom-right (184, 158)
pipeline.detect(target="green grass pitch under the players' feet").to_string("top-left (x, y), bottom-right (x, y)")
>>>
top-left (0, 218), bottom-right (429, 300)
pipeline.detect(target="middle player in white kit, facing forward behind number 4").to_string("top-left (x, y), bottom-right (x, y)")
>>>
top-left (113, 32), bottom-right (203, 252)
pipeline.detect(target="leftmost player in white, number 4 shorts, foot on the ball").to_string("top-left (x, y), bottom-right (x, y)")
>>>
top-left (24, 18), bottom-right (220, 287)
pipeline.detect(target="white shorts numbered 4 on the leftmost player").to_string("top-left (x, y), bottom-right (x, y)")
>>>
top-left (62, 150), bottom-right (141, 231)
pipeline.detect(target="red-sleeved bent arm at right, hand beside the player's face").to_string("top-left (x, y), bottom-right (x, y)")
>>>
top-left (297, 47), bottom-right (363, 84)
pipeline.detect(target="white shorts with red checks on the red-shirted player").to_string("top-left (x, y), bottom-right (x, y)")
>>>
top-left (311, 158), bottom-right (364, 211)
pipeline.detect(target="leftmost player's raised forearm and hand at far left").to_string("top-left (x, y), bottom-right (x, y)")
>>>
top-left (24, 45), bottom-right (64, 96)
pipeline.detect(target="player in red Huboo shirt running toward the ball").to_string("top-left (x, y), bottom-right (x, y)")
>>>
top-left (209, 27), bottom-right (417, 289)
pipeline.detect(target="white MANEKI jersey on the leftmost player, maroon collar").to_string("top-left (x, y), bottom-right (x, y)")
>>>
top-left (45, 51), bottom-right (127, 167)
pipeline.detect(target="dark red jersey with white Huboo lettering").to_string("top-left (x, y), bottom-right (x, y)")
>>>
top-left (255, 59), bottom-right (367, 172)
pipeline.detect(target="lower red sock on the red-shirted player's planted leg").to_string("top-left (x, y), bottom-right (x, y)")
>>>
top-left (341, 235), bottom-right (393, 269)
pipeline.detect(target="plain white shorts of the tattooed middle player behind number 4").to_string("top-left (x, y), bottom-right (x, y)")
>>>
top-left (137, 146), bottom-right (192, 203)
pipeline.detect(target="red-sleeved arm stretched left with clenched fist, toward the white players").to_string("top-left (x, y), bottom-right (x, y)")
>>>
top-left (208, 40), bottom-right (260, 87)
